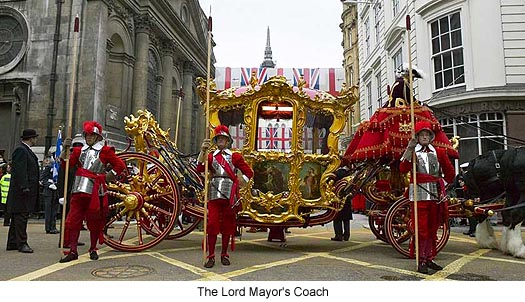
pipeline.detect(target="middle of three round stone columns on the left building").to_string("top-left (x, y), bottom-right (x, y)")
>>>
top-left (159, 40), bottom-right (177, 137)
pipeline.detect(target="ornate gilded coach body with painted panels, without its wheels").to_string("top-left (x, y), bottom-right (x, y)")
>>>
top-left (199, 76), bottom-right (357, 226)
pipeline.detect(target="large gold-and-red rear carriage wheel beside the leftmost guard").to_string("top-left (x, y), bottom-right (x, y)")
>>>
top-left (105, 152), bottom-right (180, 252)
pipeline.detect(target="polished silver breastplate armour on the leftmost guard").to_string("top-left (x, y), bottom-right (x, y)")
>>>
top-left (71, 148), bottom-right (104, 194)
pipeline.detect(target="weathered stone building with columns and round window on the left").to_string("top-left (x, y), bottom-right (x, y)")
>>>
top-left (0, 0), bottom-right (209, 157)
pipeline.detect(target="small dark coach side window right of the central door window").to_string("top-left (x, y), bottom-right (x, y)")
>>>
top-left (303, 109), bottom-right (334, 154)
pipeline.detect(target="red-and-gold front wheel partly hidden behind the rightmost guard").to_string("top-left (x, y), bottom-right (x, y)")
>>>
top-left (384, 197), bottom-right (450, 258)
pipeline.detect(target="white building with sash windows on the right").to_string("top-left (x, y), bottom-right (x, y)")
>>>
top-left (344, 0), bottom-right (525, 165)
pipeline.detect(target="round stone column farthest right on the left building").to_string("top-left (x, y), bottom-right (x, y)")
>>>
top-left (179, 61), bottom-right (195, 153)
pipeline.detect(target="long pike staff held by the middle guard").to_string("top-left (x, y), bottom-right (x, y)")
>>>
top-left (202, 6), bottom-right (212, 264)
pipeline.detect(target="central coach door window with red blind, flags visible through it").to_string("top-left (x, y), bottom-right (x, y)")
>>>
top-left (254, 101), bottom-right (293, 152)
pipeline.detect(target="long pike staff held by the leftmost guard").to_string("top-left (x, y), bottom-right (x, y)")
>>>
top-left (60, 14), bottom-right (80, 256)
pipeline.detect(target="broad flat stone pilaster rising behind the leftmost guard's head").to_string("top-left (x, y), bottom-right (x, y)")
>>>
top-left (75, 0), bottom-right (108, 125)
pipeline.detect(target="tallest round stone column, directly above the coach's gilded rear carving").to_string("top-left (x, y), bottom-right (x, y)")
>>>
top-left (131, 14), bottom-right (151, 114)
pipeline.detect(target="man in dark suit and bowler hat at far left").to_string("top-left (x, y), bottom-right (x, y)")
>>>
top-left (6, 129), bottom-right (40, 253)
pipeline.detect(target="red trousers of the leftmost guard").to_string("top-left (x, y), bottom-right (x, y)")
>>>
top-left (64, 193), bottom-right (105, 254)
